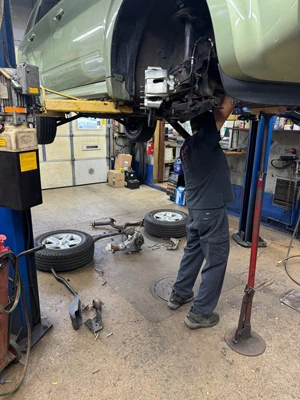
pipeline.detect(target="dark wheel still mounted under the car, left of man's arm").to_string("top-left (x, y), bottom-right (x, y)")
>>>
top-left (124, 118), bottom-right (155, 143)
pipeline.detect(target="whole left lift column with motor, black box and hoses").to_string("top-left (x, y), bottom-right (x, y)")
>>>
top-left (0, 0), bottom-right (52, 396)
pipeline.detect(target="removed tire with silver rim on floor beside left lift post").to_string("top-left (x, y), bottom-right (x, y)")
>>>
top-left (35, 229), bottom-right (94, 272)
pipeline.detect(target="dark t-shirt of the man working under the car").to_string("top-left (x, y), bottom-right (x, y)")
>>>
top-left (181, 112), bottom-right (234, 210)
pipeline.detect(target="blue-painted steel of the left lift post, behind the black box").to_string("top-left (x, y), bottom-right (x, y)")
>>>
top-left (0, 0), bottom-right (52, 350)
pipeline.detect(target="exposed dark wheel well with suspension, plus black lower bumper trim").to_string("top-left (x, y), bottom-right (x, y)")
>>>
top-left (112, 0), bottom-right (300, 141)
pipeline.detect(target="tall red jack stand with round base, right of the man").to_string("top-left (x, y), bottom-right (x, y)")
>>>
top-left (225, 117), bottom-right (270, 357)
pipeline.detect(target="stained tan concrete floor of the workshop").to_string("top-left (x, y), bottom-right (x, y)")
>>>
top-left (1, 184), bottom-right (300, 400)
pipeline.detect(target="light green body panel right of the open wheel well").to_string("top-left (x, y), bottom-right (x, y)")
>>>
top-left (207, 0), bottom-right (300, 83)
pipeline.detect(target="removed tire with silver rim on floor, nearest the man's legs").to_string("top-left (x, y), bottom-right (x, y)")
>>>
top-left (144, 210), bottom-right (188, 239)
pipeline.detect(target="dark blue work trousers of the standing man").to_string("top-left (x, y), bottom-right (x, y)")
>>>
top-left (174, 207), bottom-right (230, 316)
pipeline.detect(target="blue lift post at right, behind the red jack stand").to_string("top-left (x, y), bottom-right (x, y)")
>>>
top-left (233, 116), bottom-right (274, 247)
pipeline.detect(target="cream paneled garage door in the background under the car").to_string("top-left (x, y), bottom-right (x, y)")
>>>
top-left (39, 118), bottom-right (108, 189)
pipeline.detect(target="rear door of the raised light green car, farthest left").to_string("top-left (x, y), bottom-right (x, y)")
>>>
top-left (19, 0), bottom-right (61, 86)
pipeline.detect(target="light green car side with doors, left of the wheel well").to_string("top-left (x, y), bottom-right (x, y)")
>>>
top-left (19, 0), bottom-right (125, 100)
